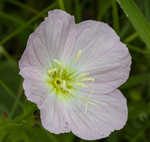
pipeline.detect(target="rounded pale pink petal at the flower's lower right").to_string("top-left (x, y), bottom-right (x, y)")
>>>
top-left (68, 90), bottom-right (128, 140)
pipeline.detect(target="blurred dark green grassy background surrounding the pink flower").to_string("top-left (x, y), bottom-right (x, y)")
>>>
top-left (0, 0), bottom-right (150, 142)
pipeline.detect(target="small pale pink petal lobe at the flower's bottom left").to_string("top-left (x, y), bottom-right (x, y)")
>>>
top-left (39, 94), bottom-right (70, 134)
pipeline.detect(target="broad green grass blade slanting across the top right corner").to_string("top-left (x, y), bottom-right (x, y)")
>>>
top-left (118, 0), bottom-right (150, 49)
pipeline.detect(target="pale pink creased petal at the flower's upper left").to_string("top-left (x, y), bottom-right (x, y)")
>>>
top-left (19, 10), bottom-right (75, 70)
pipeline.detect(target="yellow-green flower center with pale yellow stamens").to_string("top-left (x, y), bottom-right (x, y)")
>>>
top-left (46, 51), bottom-right (94, 100)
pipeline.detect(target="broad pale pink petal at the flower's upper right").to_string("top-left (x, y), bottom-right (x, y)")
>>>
top-left (60, 20), bottom-right (131, 93)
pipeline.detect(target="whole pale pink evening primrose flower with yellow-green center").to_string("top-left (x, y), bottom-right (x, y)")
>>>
top-left (19, 10), bottom-right (131, 140)
